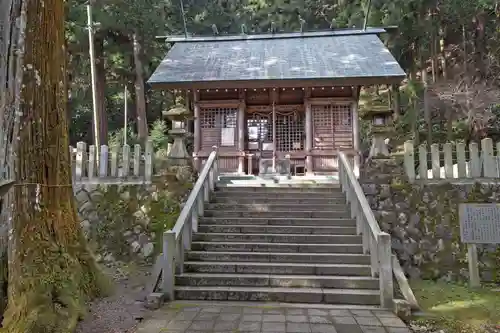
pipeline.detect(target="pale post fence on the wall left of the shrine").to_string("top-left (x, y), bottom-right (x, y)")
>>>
top-left (70, 141), bottom-right (154, 184)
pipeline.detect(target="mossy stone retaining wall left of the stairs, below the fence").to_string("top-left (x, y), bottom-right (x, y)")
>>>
top-left (74, 169), bottom-right (192, 264)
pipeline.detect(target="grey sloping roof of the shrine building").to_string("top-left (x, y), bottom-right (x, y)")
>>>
top-left (148, 34), bottom-right (405, 86)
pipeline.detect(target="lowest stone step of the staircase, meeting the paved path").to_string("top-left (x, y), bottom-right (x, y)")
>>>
top-left (175, 286), bottom-right (380, 305)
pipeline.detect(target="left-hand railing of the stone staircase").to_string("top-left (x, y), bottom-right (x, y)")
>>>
top-left (161, 147), bottom-right (218, 300)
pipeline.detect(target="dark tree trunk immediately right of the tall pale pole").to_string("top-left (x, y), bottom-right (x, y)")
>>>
top-left (94, 34), bottom-right (108, 145)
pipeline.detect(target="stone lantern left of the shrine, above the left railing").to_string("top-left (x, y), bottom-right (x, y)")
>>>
top-left (163, 105), bottom-right (191, 166)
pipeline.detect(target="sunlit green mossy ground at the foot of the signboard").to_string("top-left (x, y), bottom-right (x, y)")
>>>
top-left (412, 281), bottom-right (500, 333)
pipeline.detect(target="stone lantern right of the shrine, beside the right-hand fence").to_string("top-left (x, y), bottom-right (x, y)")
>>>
top-left (363, 106), bottom-right (393, 159)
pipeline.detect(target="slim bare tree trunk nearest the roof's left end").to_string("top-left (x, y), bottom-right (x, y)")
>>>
top-left (133, 33), bottom-right (148, 143)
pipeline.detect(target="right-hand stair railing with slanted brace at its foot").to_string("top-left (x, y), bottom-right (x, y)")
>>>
top-left (338, 152), bottom-right (418, 308)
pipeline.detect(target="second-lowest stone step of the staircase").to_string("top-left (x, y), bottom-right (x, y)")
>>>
top-left (175, 273), bottom-right (379, 290)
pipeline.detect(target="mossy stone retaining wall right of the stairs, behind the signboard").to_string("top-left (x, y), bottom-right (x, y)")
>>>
top-left (362, 160), bottom-right (500, 282)
